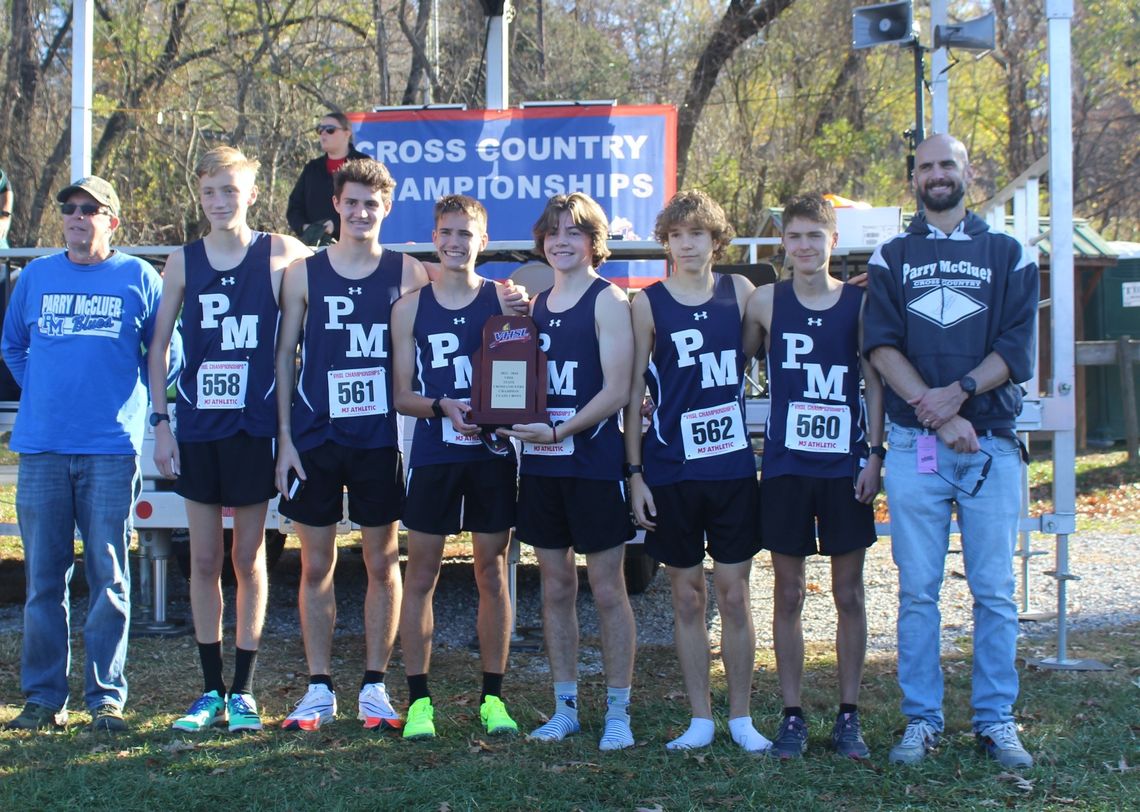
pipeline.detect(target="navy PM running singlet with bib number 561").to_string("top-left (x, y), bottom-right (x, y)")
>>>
top-left (292, 251), bottom-right (404, 452)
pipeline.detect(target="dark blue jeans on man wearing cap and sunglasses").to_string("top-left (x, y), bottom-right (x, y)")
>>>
top-left (16, 454), bottom-right (141, 709)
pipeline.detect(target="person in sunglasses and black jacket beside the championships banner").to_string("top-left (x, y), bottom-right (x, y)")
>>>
top-left (285, 112), bottom-right (368, 246)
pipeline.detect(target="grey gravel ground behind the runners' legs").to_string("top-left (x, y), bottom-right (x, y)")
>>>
top-left (0, 533), bottom-right (1140, 668)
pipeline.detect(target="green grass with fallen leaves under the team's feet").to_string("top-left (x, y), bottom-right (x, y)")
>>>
top-left (0, 627), bottom-right (1140, 812)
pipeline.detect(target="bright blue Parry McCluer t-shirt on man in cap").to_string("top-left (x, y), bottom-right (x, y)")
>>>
top-left (3, 251), bottom-right (166, 454)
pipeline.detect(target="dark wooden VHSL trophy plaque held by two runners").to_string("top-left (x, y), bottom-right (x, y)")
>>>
top-left (467, 316), bottom-right (549, 429)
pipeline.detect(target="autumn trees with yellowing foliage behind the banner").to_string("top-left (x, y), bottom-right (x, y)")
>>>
top-left (0, 0), bottom-right (1140, 245)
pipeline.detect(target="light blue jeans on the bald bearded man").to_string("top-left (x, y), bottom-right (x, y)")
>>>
top-left (886, 427), bottom-right (1021, 731)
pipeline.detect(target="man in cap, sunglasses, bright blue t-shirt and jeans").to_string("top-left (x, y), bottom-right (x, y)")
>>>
top-left (2, 177), bottom-right (180, 733)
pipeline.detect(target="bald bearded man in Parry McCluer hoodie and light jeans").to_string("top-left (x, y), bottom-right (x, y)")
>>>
top-left (863, 135), bottom-right (1040, 769)
